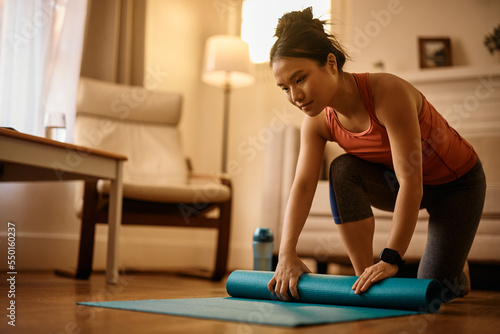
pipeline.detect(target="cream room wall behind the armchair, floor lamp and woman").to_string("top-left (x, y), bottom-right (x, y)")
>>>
top-left (0, 0), bottom-right (500, 270)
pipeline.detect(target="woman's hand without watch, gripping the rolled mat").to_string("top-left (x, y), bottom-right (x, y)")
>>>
top-left (267, 253), bottom-right (311, 302)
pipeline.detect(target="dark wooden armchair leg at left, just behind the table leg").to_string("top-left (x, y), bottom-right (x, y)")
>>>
top-left (75, 181), bottom-right (98, 279)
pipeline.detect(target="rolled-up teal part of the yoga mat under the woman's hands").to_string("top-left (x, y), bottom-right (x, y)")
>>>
top-left (226, 270), bottom-right (441, 312)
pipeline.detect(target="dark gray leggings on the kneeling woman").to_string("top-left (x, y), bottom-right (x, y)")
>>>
top-left (330, 154), bottom-right (486, 301)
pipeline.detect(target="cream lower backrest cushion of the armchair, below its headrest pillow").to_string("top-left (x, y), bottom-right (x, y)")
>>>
top-left (75, 113), bottom-right (188, 186)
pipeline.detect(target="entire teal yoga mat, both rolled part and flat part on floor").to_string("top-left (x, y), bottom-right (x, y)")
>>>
top-left (78, 270), bottom-right (441, 327)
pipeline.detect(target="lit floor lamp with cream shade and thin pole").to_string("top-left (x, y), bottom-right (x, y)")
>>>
top-left (202, 35), bottom-right (254, 173)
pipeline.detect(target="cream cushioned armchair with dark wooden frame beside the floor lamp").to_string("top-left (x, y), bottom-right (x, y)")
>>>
top-left (74, 78), bottom-right (232, 280)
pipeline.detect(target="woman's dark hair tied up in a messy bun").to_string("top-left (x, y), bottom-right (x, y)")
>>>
top-left (270, 7), bottom-right (347, 71)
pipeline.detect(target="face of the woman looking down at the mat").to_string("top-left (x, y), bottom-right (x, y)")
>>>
top-left (272, 55), bottom-right (338, 117)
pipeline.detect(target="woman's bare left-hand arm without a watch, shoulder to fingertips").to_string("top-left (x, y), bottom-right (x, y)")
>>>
top-left (268, 113), bottom-right (326, 301)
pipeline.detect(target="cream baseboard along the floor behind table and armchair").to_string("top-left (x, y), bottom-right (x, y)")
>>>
top-left (0, 232), bottom-right (252, 271)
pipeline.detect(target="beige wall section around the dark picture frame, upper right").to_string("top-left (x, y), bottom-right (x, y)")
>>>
top-left (344, 0), bottom-right (500, 72)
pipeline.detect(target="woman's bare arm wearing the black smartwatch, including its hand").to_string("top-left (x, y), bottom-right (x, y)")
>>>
top-left (353, 74), bottom-right (423, 293)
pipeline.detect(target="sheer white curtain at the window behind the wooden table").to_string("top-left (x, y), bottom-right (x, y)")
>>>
top-left (0, 0), bottom-right (87, 138)
